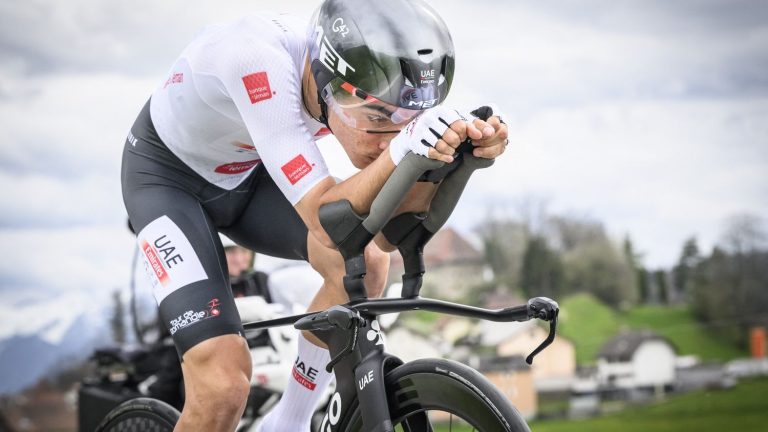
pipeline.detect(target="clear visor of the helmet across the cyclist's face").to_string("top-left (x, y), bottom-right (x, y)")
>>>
top-left (321, 77), bottom-right (422, 131)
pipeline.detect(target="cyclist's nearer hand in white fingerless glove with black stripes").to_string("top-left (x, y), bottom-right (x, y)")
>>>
top-left (389, 107), bottom-right (467, 165)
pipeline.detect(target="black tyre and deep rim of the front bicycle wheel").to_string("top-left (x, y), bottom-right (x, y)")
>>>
top-left (341, 359), bottom-right (530, 432)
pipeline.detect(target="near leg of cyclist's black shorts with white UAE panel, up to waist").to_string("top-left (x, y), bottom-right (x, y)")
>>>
top-left (122, 102), bottom-right (243, 355)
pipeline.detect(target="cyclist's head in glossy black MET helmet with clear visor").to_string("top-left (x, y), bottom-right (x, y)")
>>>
top-left (308, 0), bottom-right (454, 132)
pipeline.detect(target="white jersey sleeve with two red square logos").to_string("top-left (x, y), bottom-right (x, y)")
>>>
top-left (217, 30), bottom-right (329, 205)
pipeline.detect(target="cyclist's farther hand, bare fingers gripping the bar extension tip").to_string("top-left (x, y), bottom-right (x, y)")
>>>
top-left (464, 104), bottom-right (509, 159)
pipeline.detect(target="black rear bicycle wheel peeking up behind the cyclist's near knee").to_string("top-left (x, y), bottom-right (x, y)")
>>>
top-left (95, 398), bottom-right (180, 432)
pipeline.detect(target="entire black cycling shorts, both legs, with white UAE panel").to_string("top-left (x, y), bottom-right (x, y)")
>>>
top-left (122, 102), bottom-right (307, 356)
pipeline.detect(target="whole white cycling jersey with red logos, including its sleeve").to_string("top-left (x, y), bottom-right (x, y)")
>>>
top-left (150, 14), bottom-right (330, 204)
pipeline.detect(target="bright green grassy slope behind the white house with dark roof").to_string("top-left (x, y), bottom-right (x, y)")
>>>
top-left (560, 294), bottom-right (748, 364)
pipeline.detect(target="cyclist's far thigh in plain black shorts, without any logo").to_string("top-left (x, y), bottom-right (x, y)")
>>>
top-left (221, 167), bottom-right (307, 261)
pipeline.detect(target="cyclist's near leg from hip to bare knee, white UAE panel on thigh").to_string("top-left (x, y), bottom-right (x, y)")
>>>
top-left (122, 100), bottom-right (251, 431)
